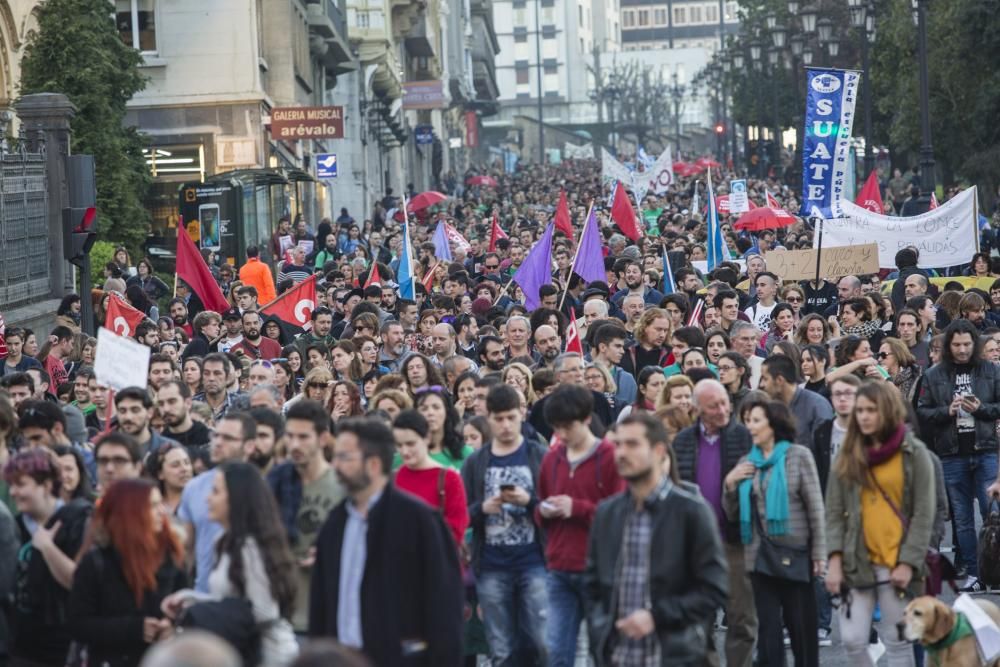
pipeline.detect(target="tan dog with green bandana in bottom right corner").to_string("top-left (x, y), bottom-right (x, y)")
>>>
top-left (898, 595), bottom-right (1000, 667)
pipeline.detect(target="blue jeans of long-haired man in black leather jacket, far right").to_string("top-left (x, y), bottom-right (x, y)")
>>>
top-left (941, 452), bottom-right (997, 577)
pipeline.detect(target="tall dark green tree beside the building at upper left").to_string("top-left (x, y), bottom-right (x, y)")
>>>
top-left (20, 0), bottom-right (151, 252)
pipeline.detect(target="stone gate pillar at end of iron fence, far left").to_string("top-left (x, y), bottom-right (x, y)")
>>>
top-left (15, 93), bottom-right (77, 299)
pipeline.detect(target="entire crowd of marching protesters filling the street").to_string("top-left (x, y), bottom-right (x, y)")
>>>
top-left (0, 160), bottom-right (1000, 667)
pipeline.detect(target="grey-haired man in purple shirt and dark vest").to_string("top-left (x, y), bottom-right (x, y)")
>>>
top-left (674, 380), bottom-right (757, 667)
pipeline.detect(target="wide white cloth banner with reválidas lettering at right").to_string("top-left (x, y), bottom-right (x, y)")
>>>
top-left (813, 187), bottom-right (979, 269)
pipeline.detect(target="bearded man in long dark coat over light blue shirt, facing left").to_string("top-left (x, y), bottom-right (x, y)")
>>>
top-left (310, 414), bottom-right (464, 665)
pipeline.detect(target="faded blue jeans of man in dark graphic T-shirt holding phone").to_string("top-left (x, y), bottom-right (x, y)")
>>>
top-left (476, 566), bottom-right (548, 667)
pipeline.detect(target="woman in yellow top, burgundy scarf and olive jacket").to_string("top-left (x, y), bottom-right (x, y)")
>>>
top-left (826, 381), bottom-right (936, 667)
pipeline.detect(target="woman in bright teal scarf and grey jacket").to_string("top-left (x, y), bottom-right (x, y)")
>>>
top-left (723, 401), bottom-right (826, 667)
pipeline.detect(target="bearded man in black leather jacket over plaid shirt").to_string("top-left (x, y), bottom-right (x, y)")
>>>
top-left (584, 413), bottom-right (728, 667)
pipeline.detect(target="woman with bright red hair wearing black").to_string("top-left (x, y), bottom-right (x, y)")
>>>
top-left (66, 479), bottom-right (188, 667)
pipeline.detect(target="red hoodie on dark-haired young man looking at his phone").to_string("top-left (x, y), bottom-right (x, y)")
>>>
top-left (535, 439), bottom-right (625, 572)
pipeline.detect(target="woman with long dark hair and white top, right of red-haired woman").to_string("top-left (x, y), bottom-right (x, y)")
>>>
top-left (162, 463), bottom-right (299, 667)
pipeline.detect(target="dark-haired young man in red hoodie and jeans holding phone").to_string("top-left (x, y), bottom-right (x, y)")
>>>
top-left (535, 384), bottom-right (625, 667)
